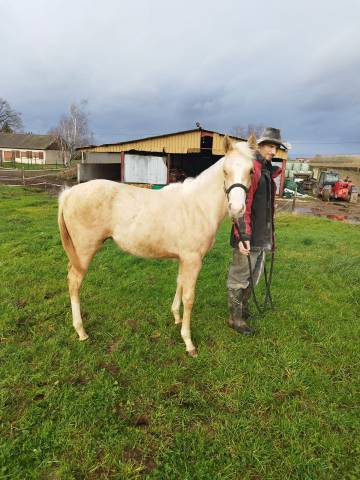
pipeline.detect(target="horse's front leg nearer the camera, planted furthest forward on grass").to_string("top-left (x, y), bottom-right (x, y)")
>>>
top-left (181, 254), bottom-right (201, 357)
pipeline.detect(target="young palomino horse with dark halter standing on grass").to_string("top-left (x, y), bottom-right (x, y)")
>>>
top-left (58, 136), bottom-right (256, 357)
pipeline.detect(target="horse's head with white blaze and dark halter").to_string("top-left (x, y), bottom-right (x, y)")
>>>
top-left (224, 135), bottom-right (256, 220)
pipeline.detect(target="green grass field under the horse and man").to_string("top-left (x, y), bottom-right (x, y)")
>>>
top-left (0, 187), bottom-right (360, 480)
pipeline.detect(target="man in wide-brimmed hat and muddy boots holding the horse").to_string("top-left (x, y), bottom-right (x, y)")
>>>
top-left (227, 127), bottom-right (286, 335)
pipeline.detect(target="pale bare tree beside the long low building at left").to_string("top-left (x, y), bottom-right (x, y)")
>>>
top-left (49, 100), bottom-right (95, 166)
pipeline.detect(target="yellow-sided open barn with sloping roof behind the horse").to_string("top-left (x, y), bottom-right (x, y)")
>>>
top-left (78, 128), bottom-right (287, 191)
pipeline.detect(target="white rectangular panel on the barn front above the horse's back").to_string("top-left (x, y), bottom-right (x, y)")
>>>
top-left (124, 154), bottom-right (167, 185)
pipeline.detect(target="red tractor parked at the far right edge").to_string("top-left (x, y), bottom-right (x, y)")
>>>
top-left (314, 172), bottom-right (358, 203)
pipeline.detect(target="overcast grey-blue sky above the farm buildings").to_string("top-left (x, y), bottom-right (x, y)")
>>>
top-left (0, 0), bottom-right (360, 156)
